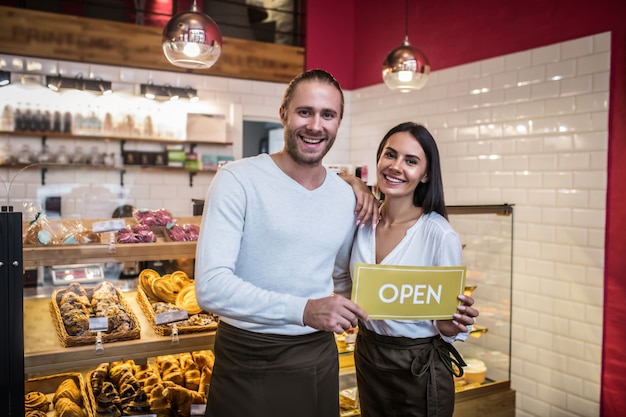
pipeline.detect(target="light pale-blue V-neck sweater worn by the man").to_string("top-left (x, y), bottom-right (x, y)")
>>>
top-left (195, 154), bottom-right (356, 335)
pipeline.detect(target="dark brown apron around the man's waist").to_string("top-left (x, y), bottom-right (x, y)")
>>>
top-left (206, 322), bottom-right (339, 417)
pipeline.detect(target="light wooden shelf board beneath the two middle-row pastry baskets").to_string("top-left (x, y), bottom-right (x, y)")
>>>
top-left (24, 291), bottom-right (215, 376)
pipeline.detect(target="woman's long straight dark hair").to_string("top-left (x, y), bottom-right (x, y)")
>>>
top-left (376, 122), bottom-right (448, 219)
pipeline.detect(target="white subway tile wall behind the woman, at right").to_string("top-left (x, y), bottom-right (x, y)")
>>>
top-left (349, 33), bottom-right (610, 417)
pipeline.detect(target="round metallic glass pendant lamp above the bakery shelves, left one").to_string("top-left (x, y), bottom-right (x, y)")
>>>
top-left (163, 0), bottom-right (222, 69)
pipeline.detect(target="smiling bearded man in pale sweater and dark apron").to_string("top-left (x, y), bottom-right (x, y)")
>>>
top-left (195, 70), bottom-right (370, 417)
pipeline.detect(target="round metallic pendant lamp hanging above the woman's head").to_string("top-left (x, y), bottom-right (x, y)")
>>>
top-left (383, 0), bottom-right (430, 93)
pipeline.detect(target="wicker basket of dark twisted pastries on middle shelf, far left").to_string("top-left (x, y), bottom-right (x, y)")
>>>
top-left (50, 287), bottom-right (141, 347)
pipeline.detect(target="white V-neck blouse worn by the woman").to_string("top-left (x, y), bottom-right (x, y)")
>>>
top-left (350, 212), bottom-right (468, 342)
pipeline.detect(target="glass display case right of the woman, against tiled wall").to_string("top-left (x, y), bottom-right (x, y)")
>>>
top-left (448, 205), bottom-right (513, 387)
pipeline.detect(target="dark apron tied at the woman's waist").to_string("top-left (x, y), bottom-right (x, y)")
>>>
top-left (354, 326), bottom-right (465, 417)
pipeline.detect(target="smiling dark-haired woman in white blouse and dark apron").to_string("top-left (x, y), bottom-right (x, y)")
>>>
top-left (351, 122), bottom-right (478, 417)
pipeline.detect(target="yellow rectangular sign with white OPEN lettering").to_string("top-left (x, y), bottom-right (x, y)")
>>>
top-left (352, 263), bottom-right (467, 320)
